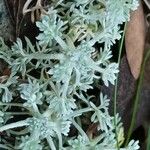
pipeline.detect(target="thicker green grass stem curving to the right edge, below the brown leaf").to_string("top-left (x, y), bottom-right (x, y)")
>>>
top-left (125, 50), bottom-right (150, 146)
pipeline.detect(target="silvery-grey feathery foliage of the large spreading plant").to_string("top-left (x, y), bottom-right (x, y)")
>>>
top-left (0, 0), bottom-right (139, 150)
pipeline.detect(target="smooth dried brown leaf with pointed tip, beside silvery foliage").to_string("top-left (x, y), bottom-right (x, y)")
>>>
top-left (125, 3), bottom-right (146, 79)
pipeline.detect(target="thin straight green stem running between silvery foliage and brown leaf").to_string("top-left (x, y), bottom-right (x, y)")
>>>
top-left (113, 23), bottom-right (127, 150)
